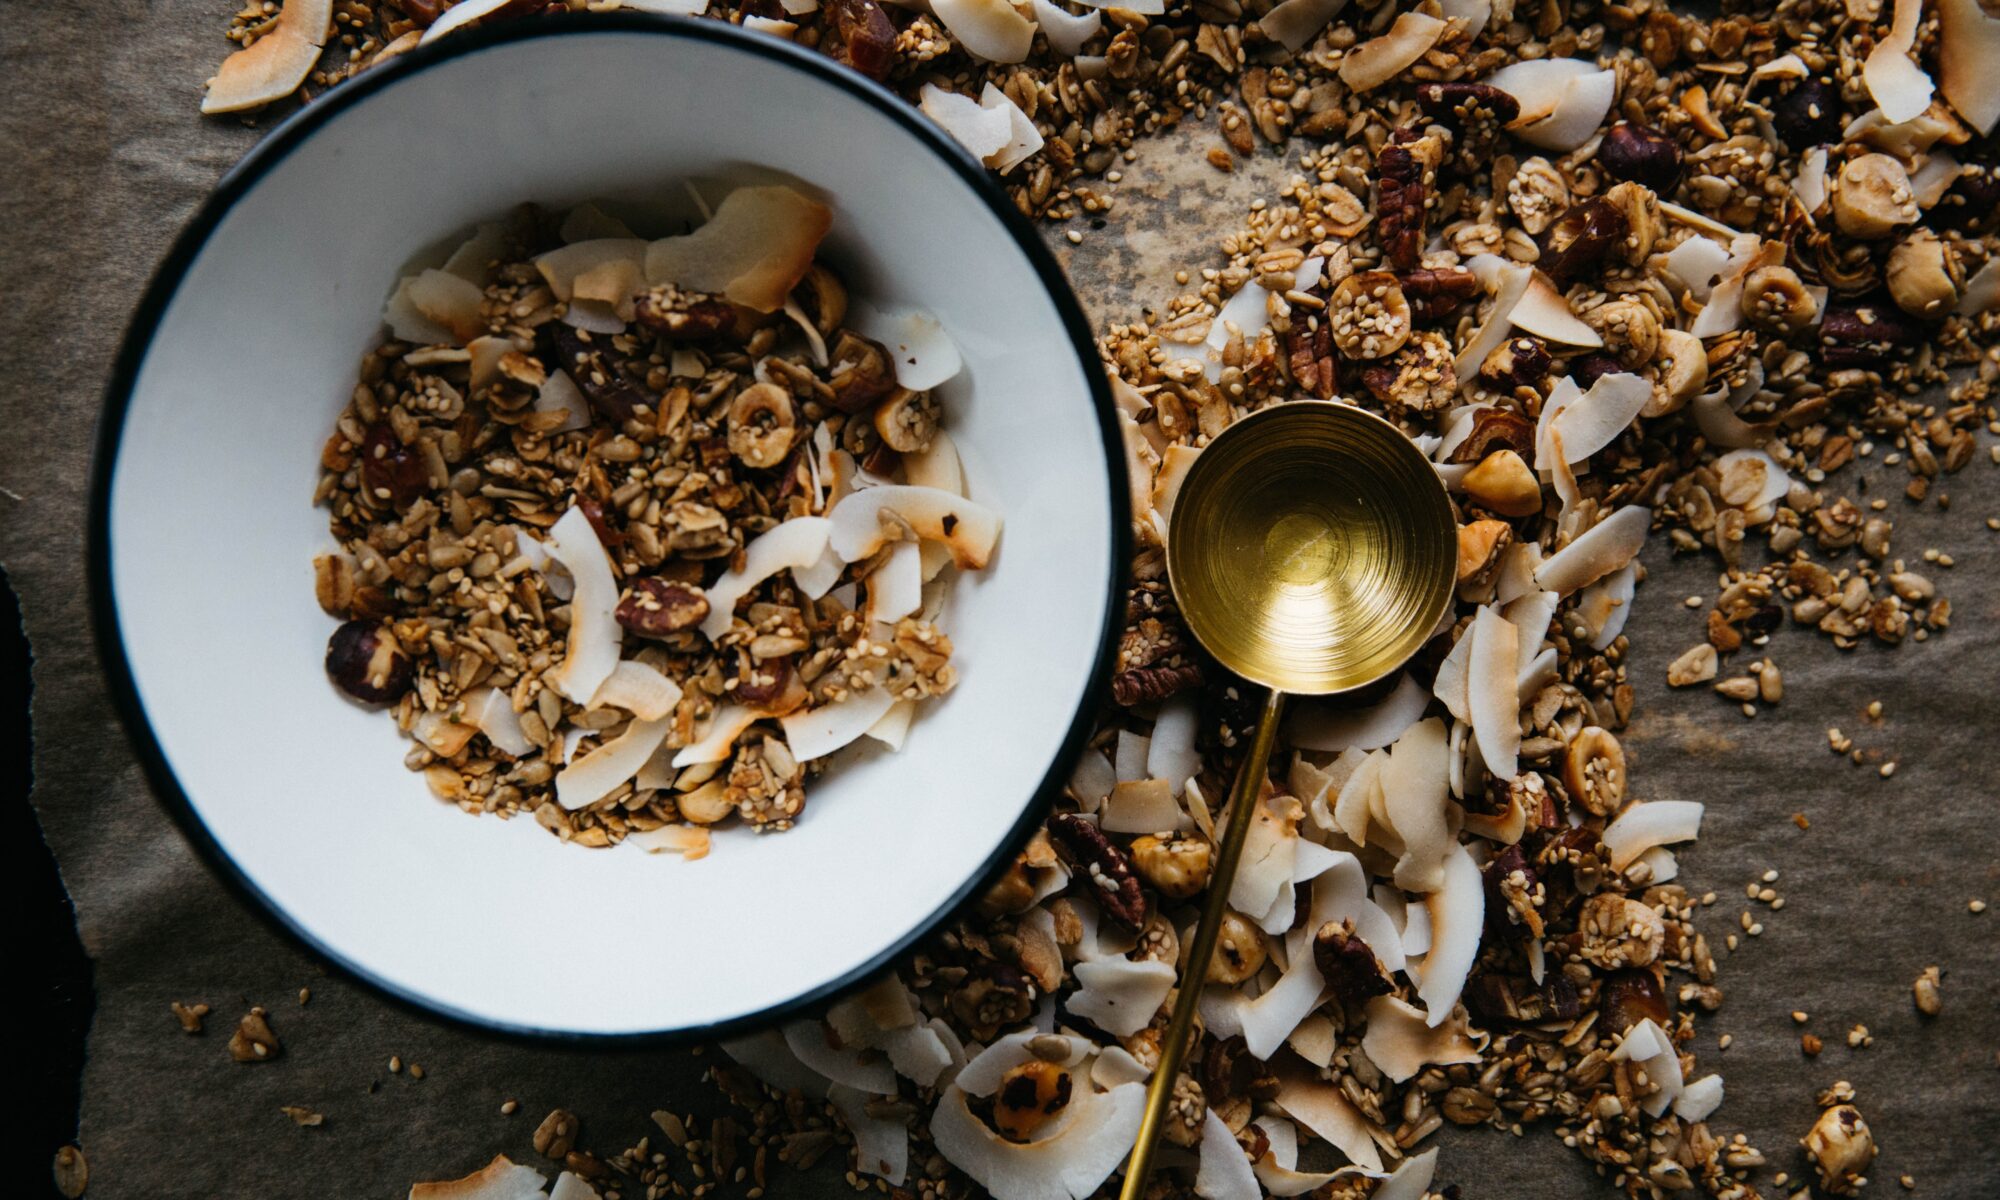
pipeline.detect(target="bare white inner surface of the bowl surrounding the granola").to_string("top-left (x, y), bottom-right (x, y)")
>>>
top-left (104, 22), bottom-right (1124, 1034)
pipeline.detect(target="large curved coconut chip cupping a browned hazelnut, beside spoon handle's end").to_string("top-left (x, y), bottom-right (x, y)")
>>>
top-left (930, 1068), bottom-right (1146, 1200)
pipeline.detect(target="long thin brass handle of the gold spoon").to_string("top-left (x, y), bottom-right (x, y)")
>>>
top-left (1118, 690), bottom-right (1284, 1200)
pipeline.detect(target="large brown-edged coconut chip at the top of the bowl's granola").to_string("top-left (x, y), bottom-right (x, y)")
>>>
top-left (646, 186), bottom-right (834, 312)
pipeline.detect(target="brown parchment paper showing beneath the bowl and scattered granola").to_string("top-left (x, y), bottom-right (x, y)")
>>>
top-left (0, 0), bottom-right (2000, 1200)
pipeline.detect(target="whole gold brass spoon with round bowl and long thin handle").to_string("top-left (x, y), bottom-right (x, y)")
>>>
top-left (1120, 400), bottom-right (1458, 1200)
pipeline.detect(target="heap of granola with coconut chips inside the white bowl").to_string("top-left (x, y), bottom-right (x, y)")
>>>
top-left (314, 186), bottom-right (1000, 858)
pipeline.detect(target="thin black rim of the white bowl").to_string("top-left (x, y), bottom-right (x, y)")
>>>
top-left (86, 12), bottom-right (1132, 1048)
